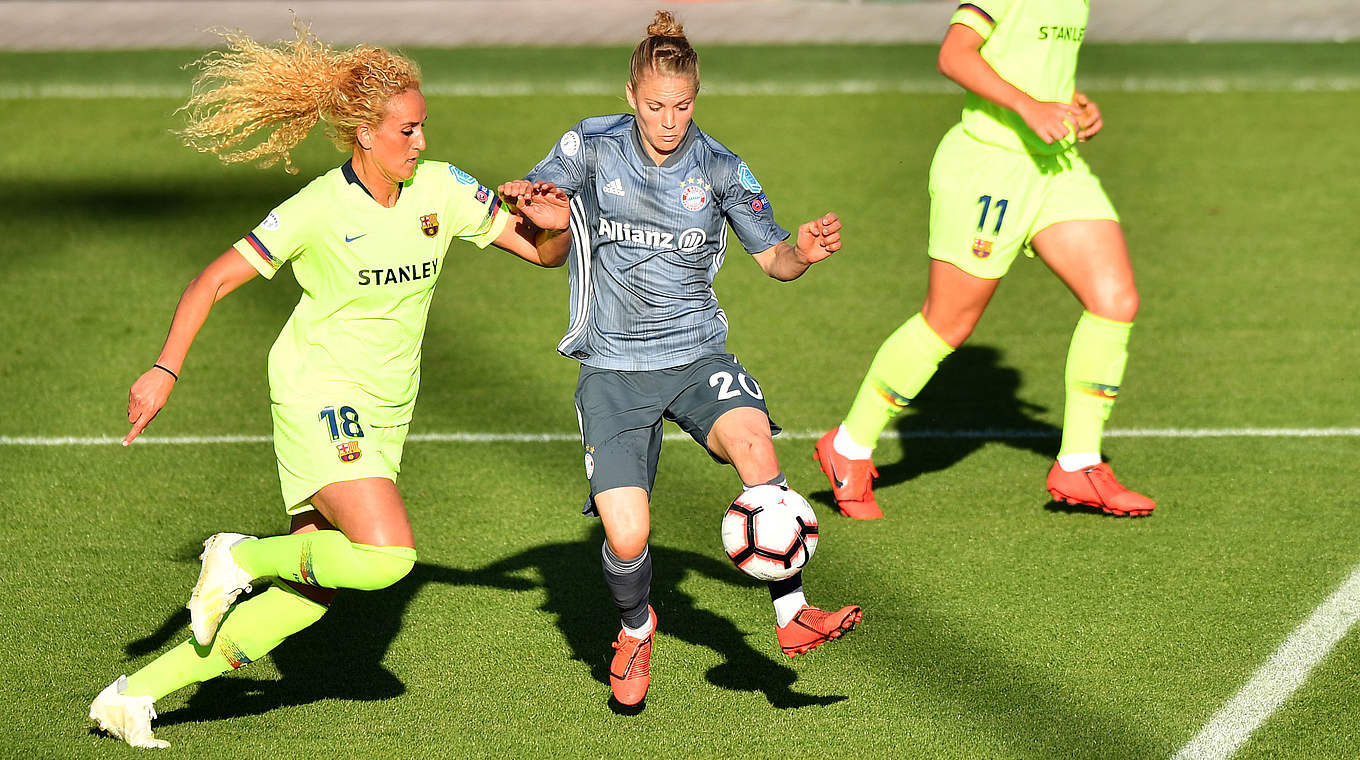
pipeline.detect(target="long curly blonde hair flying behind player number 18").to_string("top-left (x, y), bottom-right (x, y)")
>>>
top-left (178, 19), bottom-right (420, 174)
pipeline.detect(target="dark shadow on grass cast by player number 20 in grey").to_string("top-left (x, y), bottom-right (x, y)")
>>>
top-left (479, 522), bottom-right (847, 714)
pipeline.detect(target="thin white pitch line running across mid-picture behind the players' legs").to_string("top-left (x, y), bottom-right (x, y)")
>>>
top-left (0, 427), bottom-right (1360, 446)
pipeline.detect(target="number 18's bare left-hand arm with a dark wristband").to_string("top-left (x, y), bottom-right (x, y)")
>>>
top-left (122, 249), bottom-right (258, 446)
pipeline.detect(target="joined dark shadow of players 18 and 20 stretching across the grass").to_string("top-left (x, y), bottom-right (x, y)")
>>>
top-left (125, 523), bottom-right (846, 726)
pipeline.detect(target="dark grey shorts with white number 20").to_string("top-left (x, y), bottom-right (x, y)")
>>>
top-left (577, 353), bottom-right (779, 514)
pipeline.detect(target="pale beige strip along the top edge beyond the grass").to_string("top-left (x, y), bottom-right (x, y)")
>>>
top-left (0, 0), bottom-right (1360, 50)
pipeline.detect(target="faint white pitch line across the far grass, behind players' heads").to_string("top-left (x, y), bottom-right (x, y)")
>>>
top-left (0, 75), bottom-right (1360, 101)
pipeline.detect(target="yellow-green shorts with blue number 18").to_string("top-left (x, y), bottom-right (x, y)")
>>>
top-left (269, 398), bottom-right (411, 515)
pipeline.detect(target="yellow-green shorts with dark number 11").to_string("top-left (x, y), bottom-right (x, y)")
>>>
top-left (928, 124), bottom-right (1119, 280)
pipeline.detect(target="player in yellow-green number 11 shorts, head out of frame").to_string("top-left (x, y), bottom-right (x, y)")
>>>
top-left (815, 0), bottom-right (1155, 519)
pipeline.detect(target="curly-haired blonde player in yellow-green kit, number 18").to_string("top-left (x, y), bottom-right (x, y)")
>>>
top-left (90, 26), bottom-right (570, 748)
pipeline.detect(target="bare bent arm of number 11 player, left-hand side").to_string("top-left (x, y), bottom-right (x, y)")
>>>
top-left (937, 23), bottom-right (1080, 144)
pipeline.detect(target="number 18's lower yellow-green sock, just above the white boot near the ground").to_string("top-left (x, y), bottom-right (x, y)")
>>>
top-left (124, 583), bottom-right (326, 699)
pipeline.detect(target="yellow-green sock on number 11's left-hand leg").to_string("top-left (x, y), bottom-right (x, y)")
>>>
top-left (845, 314), bottom-right (953, 449)
